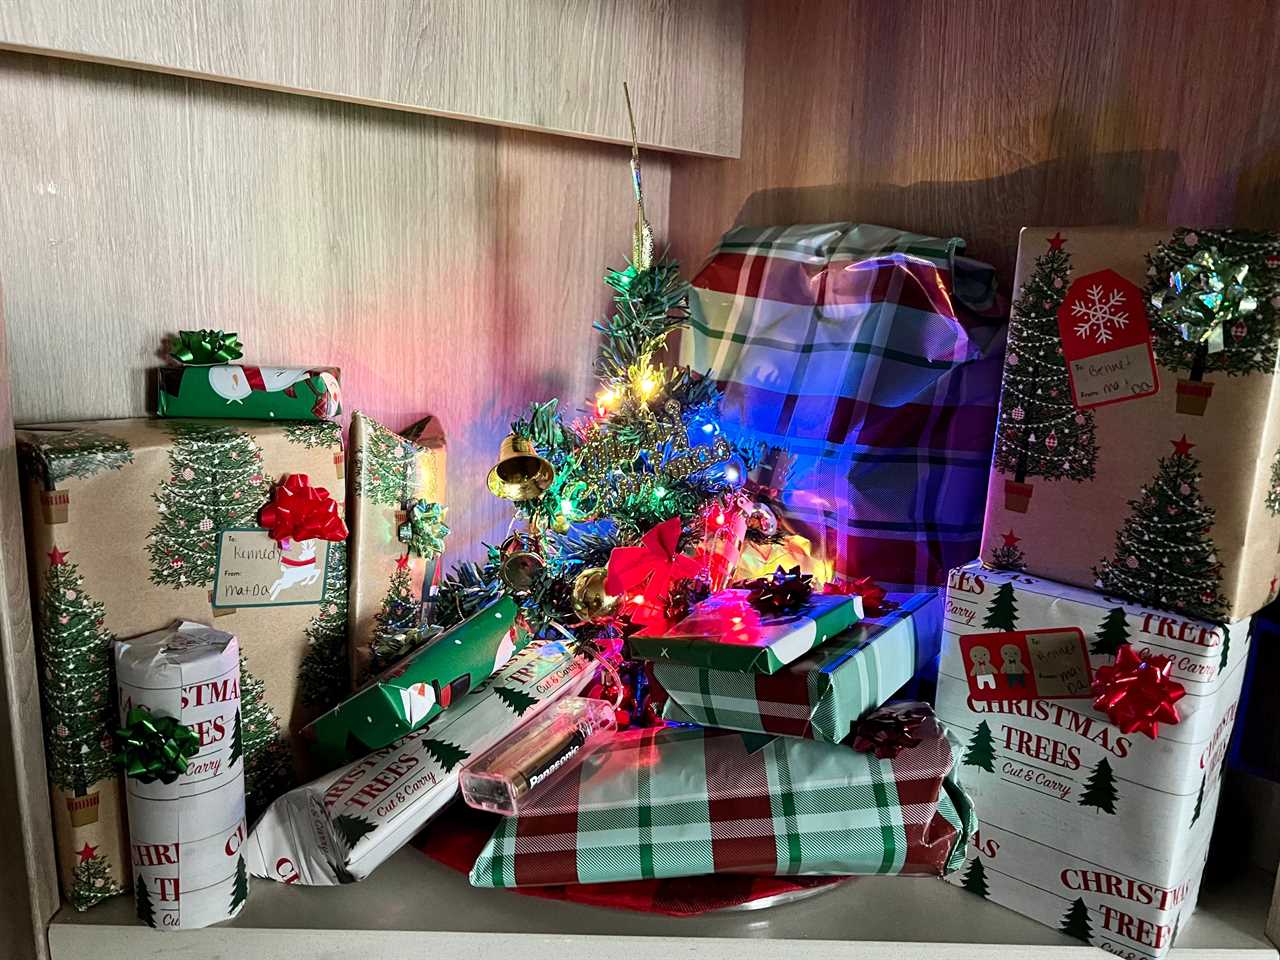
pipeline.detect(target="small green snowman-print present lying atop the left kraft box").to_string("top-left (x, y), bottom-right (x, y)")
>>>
top-left (156, 364), bottom-right (342, 420)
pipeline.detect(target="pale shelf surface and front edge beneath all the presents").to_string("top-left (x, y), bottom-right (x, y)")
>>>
top-left (49, 849), bottom-right (1280, 960)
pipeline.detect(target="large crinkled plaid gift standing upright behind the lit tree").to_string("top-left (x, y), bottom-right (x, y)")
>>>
top-left (681, 223), bottom-right (1005, 591)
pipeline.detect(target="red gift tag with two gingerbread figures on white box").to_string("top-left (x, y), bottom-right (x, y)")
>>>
top-left (960, 627), bottom-right (1093, 701)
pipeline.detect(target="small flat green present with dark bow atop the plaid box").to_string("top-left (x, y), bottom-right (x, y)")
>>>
top-left (627, 588), bottom-right (863, 673)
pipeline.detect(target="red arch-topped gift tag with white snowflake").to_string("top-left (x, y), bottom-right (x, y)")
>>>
top-left (1057, 270), bottom-right (1160, 408)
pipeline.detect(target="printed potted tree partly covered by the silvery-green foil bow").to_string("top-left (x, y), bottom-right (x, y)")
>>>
top-left (1147, 229), bottom-right (1280, 416)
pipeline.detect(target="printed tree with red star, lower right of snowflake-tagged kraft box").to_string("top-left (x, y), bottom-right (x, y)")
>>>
top-left (1093, 434), bottom-right (1226, 621)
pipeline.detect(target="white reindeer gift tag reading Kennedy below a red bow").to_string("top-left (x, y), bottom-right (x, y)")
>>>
top-left (212, 527), bottom-right (329, 608)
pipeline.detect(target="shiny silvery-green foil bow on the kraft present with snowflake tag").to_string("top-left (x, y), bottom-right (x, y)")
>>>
top-left (1151, 250), bottom-right (1258, 353)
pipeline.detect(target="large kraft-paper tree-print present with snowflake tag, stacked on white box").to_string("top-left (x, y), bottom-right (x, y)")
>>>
top-left (982, 227), bottom-right (1280, 621)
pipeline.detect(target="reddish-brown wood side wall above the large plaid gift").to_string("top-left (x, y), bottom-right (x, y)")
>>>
top-left (672, 0), bottom-right (1280, 281)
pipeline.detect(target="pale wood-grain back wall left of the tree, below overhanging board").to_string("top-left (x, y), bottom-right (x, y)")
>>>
top-left (0, 54), bottom-right (669, 558)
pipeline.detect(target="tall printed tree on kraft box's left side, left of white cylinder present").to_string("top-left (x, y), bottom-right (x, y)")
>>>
top-left (40, 547), bottom-right (115, 796)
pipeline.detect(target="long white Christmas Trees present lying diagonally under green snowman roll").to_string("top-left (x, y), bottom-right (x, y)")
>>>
top-left (246, 643), bottom-right (595, 886)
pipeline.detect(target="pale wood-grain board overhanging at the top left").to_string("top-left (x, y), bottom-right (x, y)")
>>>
top-left (0, 0), bottom-right (742, 156)
